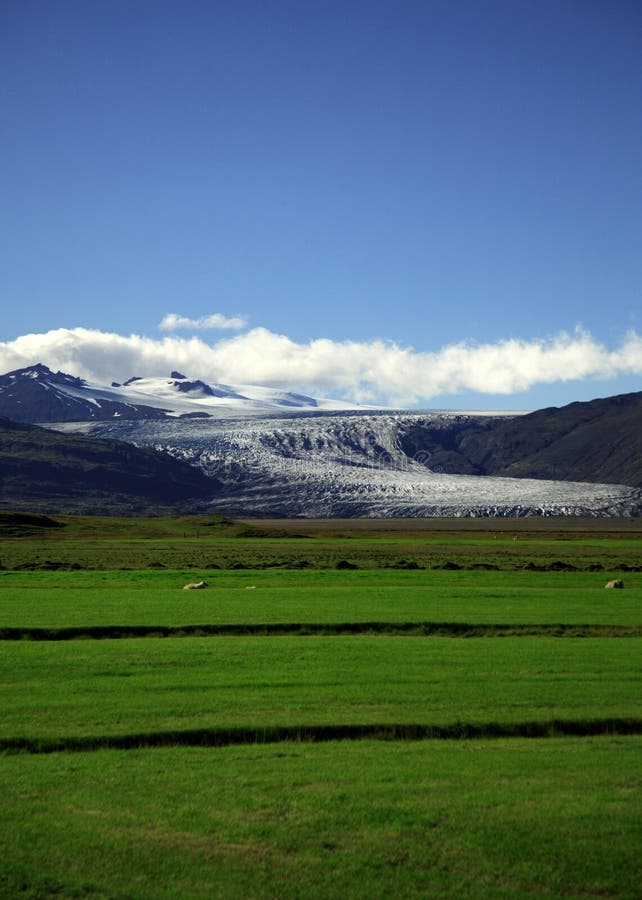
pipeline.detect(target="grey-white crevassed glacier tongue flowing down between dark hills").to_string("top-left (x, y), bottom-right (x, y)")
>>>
top-left (55, 413), bottom-right (642, 517)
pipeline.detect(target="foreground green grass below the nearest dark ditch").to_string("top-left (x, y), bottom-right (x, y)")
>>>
top-left (0, 737), bottom-right (642, 898)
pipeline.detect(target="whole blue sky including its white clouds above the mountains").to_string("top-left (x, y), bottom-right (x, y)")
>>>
top-left (0, 0), bottom-right (642, 408)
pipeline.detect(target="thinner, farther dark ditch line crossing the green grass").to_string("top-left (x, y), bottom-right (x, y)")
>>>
top-left (0, 622), bottom-right (642, 641)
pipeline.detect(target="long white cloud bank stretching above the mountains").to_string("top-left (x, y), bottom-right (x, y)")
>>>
top-left (0, 328), bottom-right (642, 406)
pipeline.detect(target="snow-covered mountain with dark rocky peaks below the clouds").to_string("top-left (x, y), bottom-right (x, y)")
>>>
top-left (0, 363), bottom-right (350, 423)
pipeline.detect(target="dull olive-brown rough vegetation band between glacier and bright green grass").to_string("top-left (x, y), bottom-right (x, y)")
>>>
top-left (0, 516), bottom-right (642, 573)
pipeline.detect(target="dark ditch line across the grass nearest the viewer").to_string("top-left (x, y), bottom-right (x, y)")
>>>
top-left (0, 718), bottom-right (642, 754)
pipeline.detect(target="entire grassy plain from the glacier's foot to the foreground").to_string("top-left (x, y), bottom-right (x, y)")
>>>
top-left (0, 514), bottom-right (642, 898)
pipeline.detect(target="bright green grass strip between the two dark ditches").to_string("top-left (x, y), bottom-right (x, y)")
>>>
top-left (0, 635), bottom-right (642, 739)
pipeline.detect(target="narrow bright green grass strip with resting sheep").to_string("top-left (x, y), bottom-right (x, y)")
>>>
top-left (0, 569), bottom-right (642, 628)
